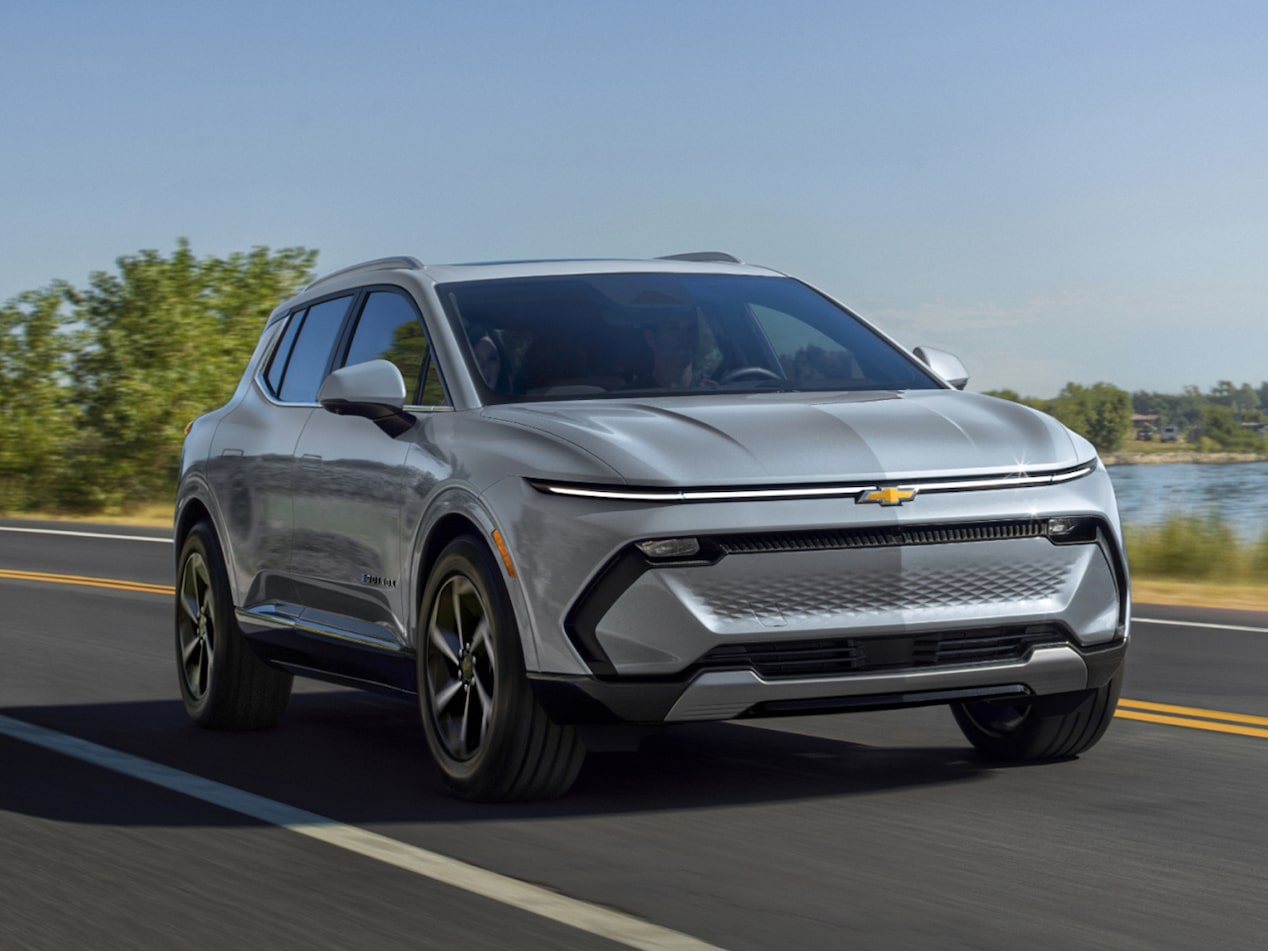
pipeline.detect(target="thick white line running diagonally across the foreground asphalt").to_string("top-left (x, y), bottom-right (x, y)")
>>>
top-left (0, 715), bottom-right (719, 951)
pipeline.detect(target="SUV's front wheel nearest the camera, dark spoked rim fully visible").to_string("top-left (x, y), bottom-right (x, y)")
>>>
top-left (417, 536), bottom-right (586, 801)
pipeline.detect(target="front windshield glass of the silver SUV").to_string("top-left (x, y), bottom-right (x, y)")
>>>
top-left (436, 274), bottom-right (938, 401)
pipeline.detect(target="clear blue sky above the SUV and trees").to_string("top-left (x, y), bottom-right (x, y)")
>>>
top-left (0, 0), bottom-right (1268, 397)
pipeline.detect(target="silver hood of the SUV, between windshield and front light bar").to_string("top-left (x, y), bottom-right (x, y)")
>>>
top-left (482, 389), bottom-right (1094, 486)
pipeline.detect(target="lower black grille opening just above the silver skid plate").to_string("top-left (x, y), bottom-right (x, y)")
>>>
top-left (696, 625), bottom-right (1069, 680)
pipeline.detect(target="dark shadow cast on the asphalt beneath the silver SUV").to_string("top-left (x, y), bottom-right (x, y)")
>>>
top-left (0, 691), bottom-right (1009, 824)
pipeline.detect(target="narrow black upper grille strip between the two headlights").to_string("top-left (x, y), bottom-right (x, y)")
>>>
top-left (711, 519), bottom-right (1046, 554)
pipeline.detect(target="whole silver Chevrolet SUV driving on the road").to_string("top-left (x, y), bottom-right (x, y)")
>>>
top-left (175, 252), bottom-right (1129, 800)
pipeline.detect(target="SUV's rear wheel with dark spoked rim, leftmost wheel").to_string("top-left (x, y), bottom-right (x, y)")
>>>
top-left (176, 521), bottom-right (293, 730)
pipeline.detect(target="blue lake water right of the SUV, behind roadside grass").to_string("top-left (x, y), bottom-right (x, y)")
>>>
top-left (1108, 463), bottom-right (1268, 540)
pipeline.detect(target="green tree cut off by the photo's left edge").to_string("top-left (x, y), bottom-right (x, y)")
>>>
top-left (0, 283), bottom-right (77, 511)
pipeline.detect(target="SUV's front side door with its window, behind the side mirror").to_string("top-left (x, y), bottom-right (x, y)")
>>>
top-left (293, 288), bottom-right (448, 648)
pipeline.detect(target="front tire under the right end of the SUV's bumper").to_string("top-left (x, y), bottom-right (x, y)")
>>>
top-left (951, 667), bottom-right (1123, 761)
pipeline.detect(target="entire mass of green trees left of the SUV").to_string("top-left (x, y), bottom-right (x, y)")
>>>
top-left (0, 241), bottom-right (317, 510)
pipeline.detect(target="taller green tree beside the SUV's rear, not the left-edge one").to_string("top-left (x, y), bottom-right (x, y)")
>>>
top-left (63, 240), bottom-right (317, 508)
